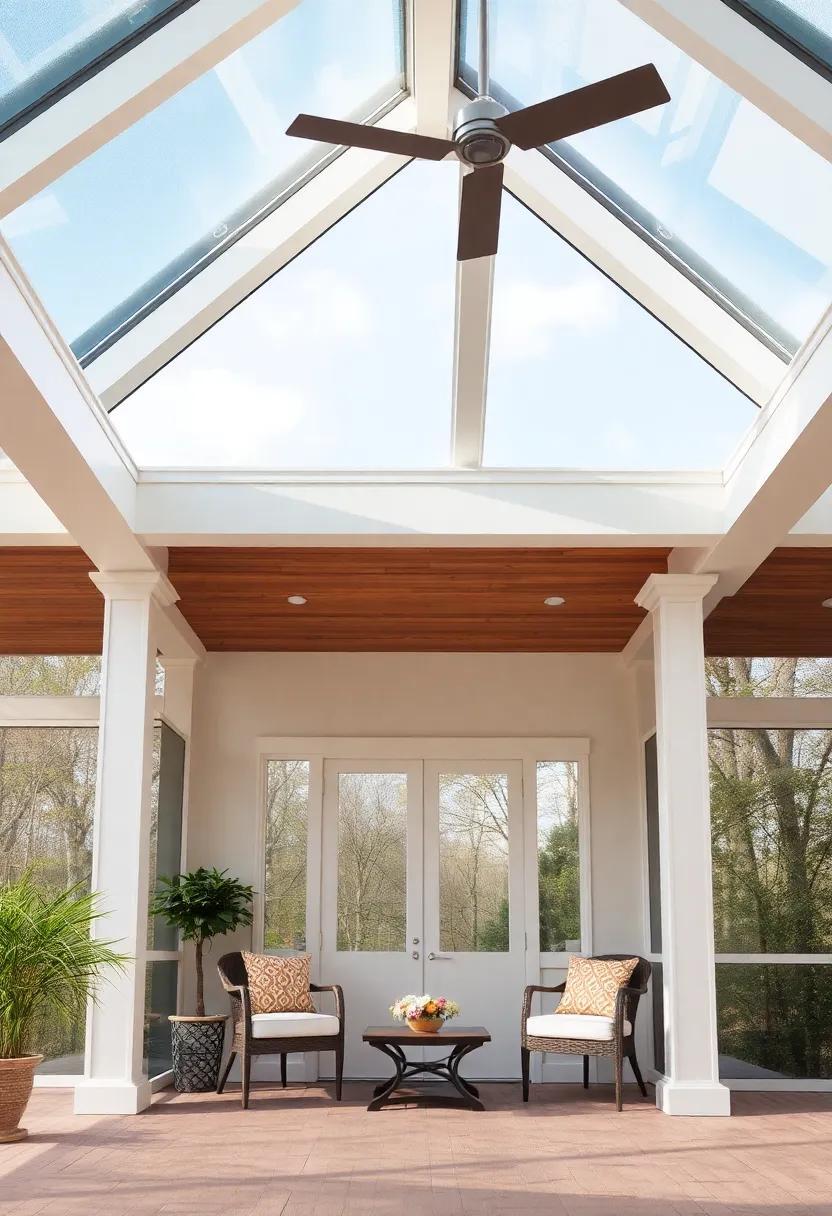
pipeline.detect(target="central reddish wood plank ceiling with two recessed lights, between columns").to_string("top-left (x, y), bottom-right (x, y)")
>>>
top-left (168, 548), bottom-right (668, 652)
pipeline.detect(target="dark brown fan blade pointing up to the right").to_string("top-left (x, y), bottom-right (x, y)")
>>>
top-left (496, 63), bottom-right (670, 148)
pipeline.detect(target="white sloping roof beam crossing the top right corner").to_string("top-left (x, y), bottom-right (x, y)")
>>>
top-left (620, 0), bottom-right (832, 161)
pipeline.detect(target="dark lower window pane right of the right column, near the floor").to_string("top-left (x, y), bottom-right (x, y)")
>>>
top-left (716, 963), bottom-right (832, 1079)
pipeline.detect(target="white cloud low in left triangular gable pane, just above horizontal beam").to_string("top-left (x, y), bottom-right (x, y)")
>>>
top-left (112, 367), bottom-right (308, 467)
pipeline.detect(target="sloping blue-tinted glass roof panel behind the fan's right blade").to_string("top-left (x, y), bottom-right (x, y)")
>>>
top-left (459, 0), bottom-right (832, 356)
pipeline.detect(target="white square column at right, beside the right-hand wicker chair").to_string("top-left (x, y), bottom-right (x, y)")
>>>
top-left (636, 574), bottom-right (731, 1115)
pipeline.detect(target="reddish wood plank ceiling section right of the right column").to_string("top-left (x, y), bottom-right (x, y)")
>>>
top-left (705, 548), bottom-right (832, 658)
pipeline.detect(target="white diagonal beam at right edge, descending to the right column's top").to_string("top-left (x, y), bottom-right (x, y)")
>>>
top-left (669, 310), bottom-right (832, 614)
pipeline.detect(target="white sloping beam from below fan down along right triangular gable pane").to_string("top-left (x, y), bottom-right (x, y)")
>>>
top-left (505, 146), bottom-right (786, 405)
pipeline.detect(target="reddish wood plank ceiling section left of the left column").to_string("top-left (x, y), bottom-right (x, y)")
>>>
top-left (0, 547), bottom-right (103, 654)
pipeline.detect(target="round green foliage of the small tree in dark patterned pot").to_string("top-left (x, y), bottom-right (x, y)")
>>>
top-left (150, 866), bottom-right (254, 944)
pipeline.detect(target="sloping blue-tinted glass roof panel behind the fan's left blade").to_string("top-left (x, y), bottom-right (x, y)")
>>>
top-left (0, 0), bottom-right (404, 362)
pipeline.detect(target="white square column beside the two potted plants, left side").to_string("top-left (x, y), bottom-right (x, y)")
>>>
top-left (75, 572), bottom-right (175, 1115)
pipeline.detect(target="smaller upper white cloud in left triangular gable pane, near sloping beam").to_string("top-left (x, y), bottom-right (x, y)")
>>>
top-left (257, 270), bottom-right (373, 349)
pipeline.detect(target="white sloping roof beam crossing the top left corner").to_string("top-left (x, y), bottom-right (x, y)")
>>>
top-left (0, 0), bottom-right (298, 216)
